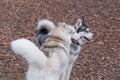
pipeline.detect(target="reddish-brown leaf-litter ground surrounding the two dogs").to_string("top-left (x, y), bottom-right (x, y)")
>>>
top-left (0, 0), bottom-right (120, 80)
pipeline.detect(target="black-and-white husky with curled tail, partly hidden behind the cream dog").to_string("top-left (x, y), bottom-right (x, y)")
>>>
top-left (35, 18), bottom-right (94, 80)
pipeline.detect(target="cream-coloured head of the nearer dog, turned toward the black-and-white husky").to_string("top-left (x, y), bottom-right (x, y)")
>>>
top-left (52, 22), bottom-right (79, 43)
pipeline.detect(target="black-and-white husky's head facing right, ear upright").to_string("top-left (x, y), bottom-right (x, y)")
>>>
top-left (72, 18), bottom-right (94, 45)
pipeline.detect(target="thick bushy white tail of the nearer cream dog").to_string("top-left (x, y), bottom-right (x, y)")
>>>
top-left (11, 39), bottom-right (47, 68)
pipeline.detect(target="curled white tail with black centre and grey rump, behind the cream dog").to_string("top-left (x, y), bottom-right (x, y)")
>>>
top-left (35, 19), bottom-right (55, 47)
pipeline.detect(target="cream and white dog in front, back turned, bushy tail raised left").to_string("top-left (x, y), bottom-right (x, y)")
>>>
top-left (11, 23), bottom-right (79, 80)
